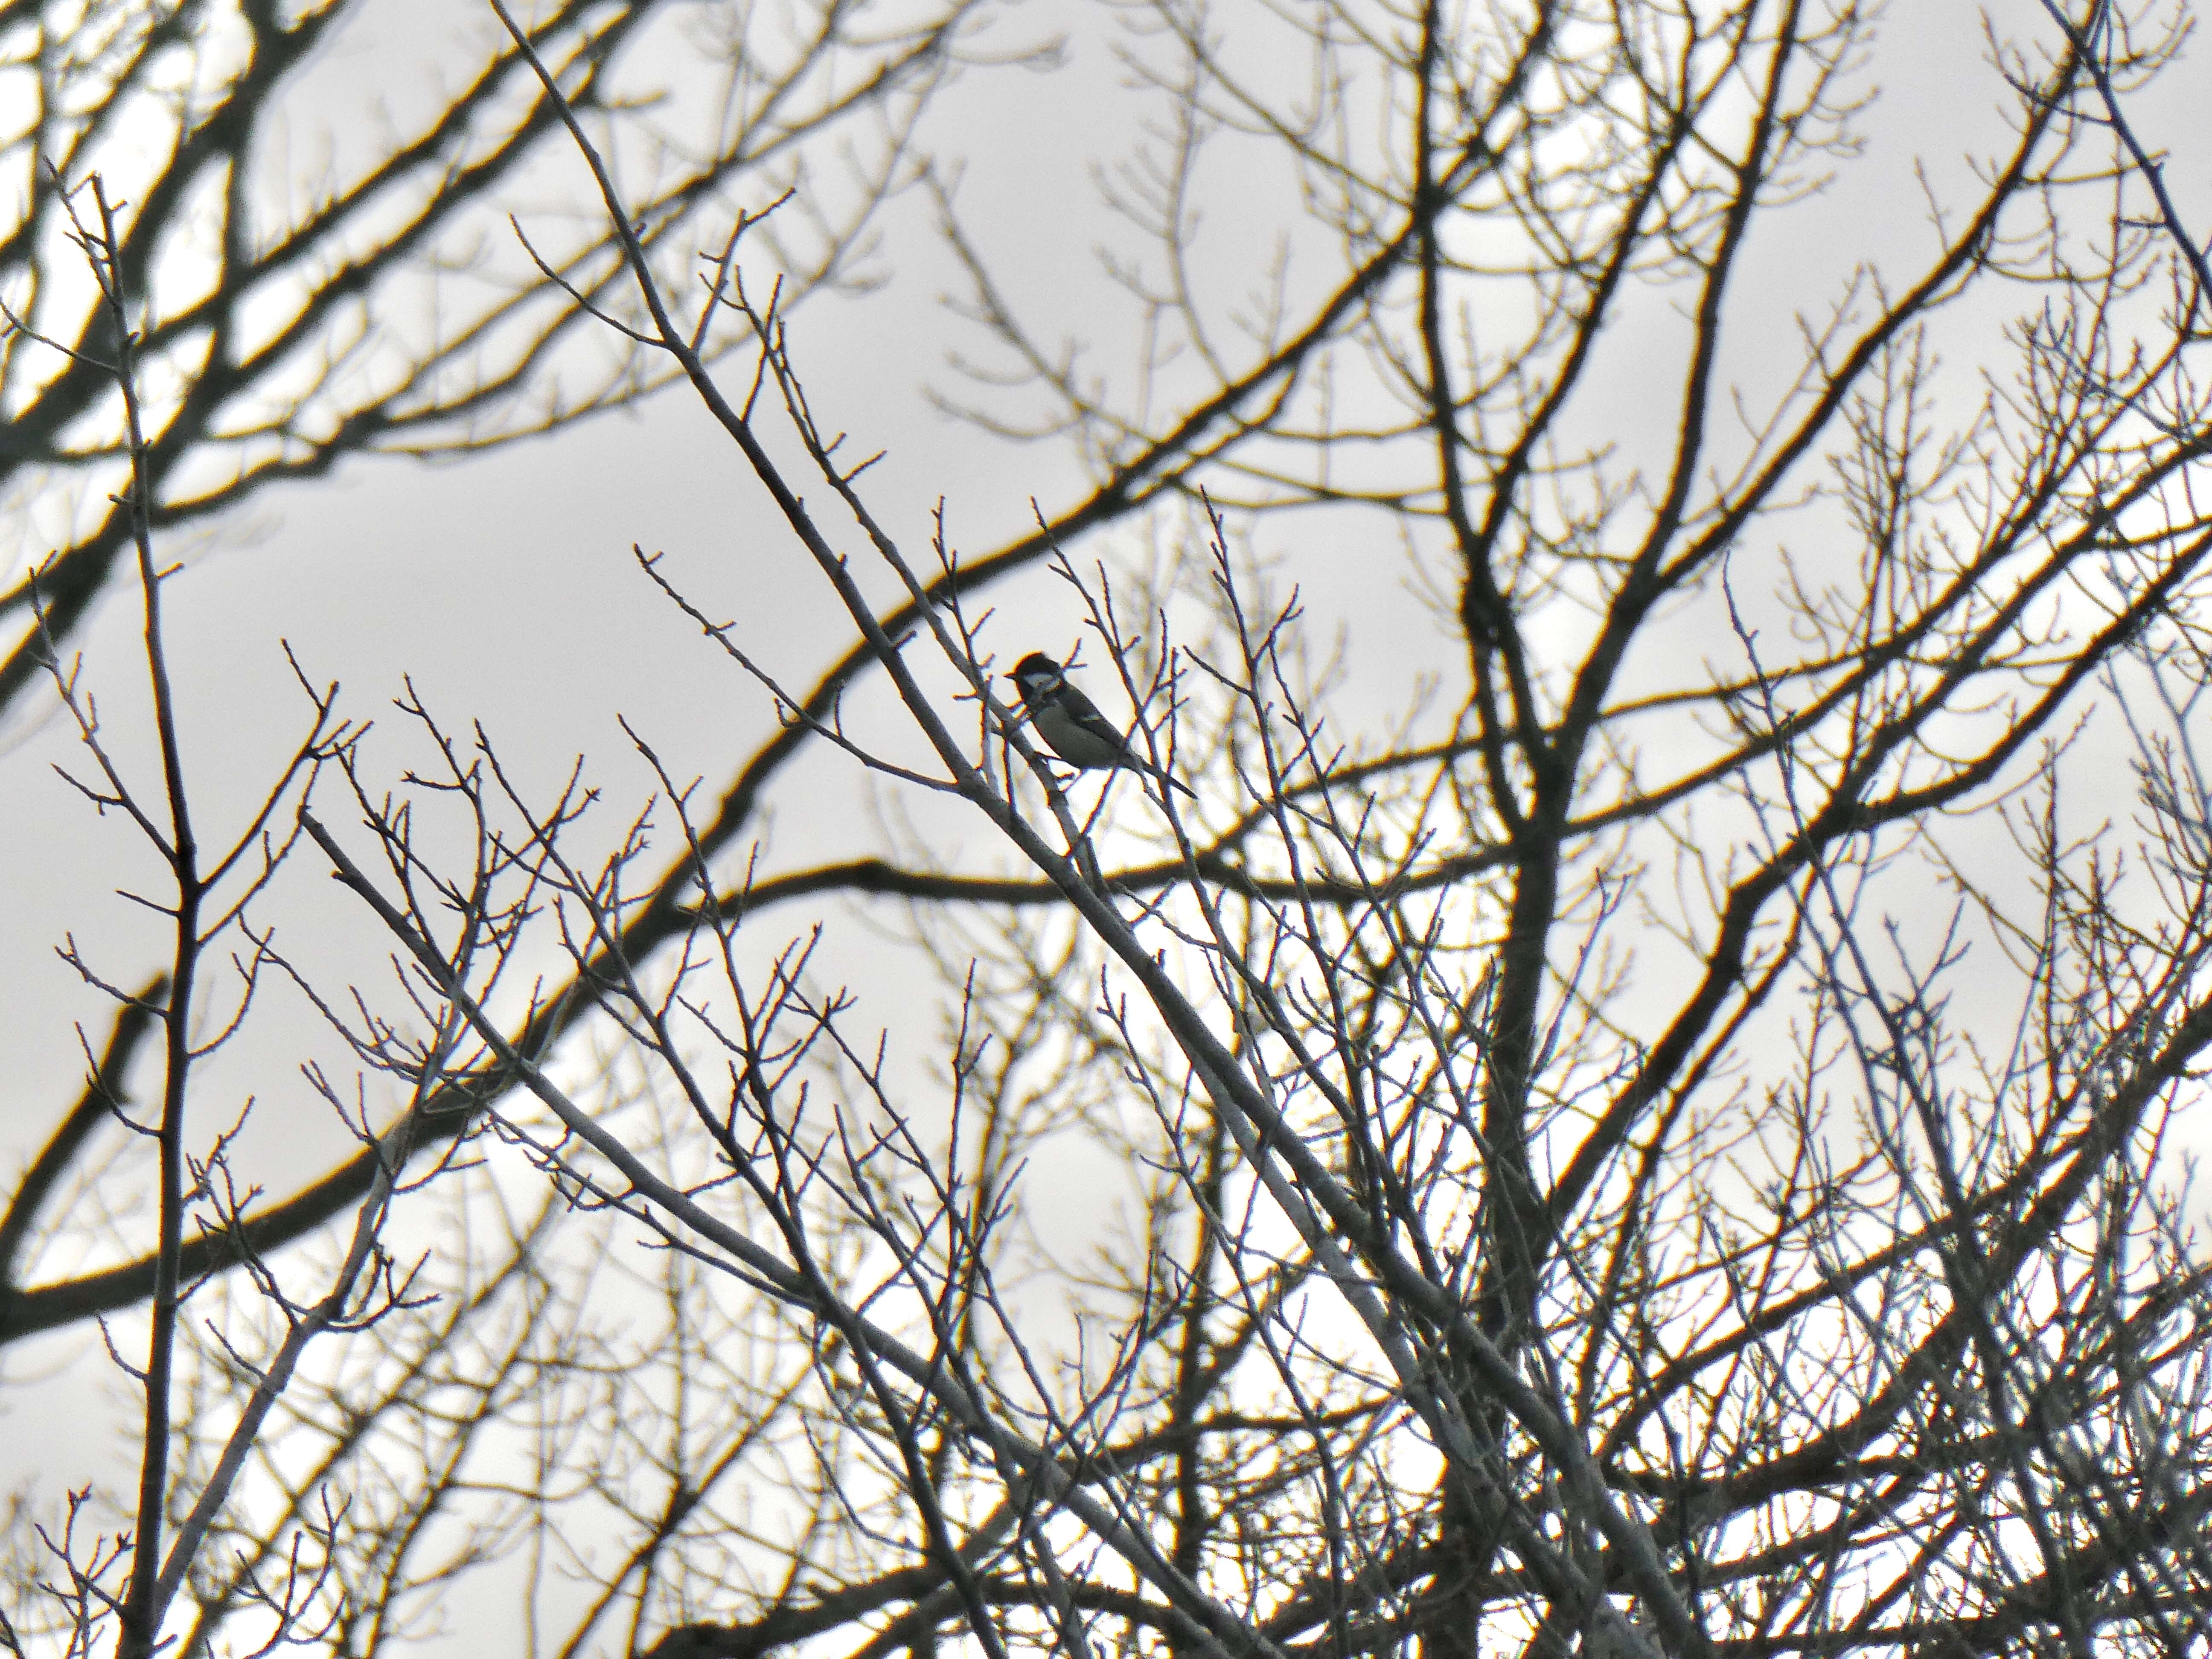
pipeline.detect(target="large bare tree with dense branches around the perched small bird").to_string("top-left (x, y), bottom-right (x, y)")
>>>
top-left (4, 0), bottom-right (2212, 1659)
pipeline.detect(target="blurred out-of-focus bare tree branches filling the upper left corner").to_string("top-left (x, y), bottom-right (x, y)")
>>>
top-left (0, 0), bottom-right (980, 706)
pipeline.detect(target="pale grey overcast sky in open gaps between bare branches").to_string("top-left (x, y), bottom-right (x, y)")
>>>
top-left (0, 0), bottom-right (2212, 1650)
